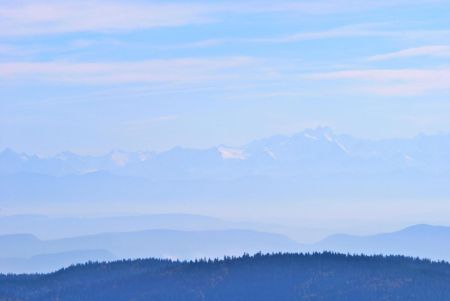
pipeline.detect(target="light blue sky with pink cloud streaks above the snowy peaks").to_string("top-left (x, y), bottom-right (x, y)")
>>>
top-left (0, 0), bottom-right (450, 155)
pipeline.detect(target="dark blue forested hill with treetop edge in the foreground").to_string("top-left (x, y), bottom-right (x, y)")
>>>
top-left (0, 253), bottom-right (450, 301)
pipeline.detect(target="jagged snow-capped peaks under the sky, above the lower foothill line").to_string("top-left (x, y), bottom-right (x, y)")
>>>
top-left (0, 127), bottom-right (450, 180)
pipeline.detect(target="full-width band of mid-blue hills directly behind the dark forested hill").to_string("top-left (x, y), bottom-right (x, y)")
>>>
top-left (0, 217), bottom-right (450, 273)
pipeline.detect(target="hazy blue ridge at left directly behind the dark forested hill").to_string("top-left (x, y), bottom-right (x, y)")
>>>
top-left (0, 229), bottom-right (300, 274)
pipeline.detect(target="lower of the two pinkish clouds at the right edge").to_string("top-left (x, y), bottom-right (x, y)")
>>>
top-left (302, 68), bottom-right (450, 96)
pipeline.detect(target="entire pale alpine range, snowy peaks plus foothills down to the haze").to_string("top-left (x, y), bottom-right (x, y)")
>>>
top-left (0, 128), bottom-right (450, 202)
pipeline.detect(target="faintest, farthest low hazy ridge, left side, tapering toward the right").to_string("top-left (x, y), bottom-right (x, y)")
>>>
top-left (0, 213), bottom-right (329, 242)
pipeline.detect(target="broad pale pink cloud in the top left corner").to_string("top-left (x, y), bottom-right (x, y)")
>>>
top-left (0, 0), bottom-right (213, 35)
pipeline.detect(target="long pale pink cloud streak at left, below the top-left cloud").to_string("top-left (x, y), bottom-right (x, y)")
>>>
top-left (0, 57), bottom-right (259, 85)
